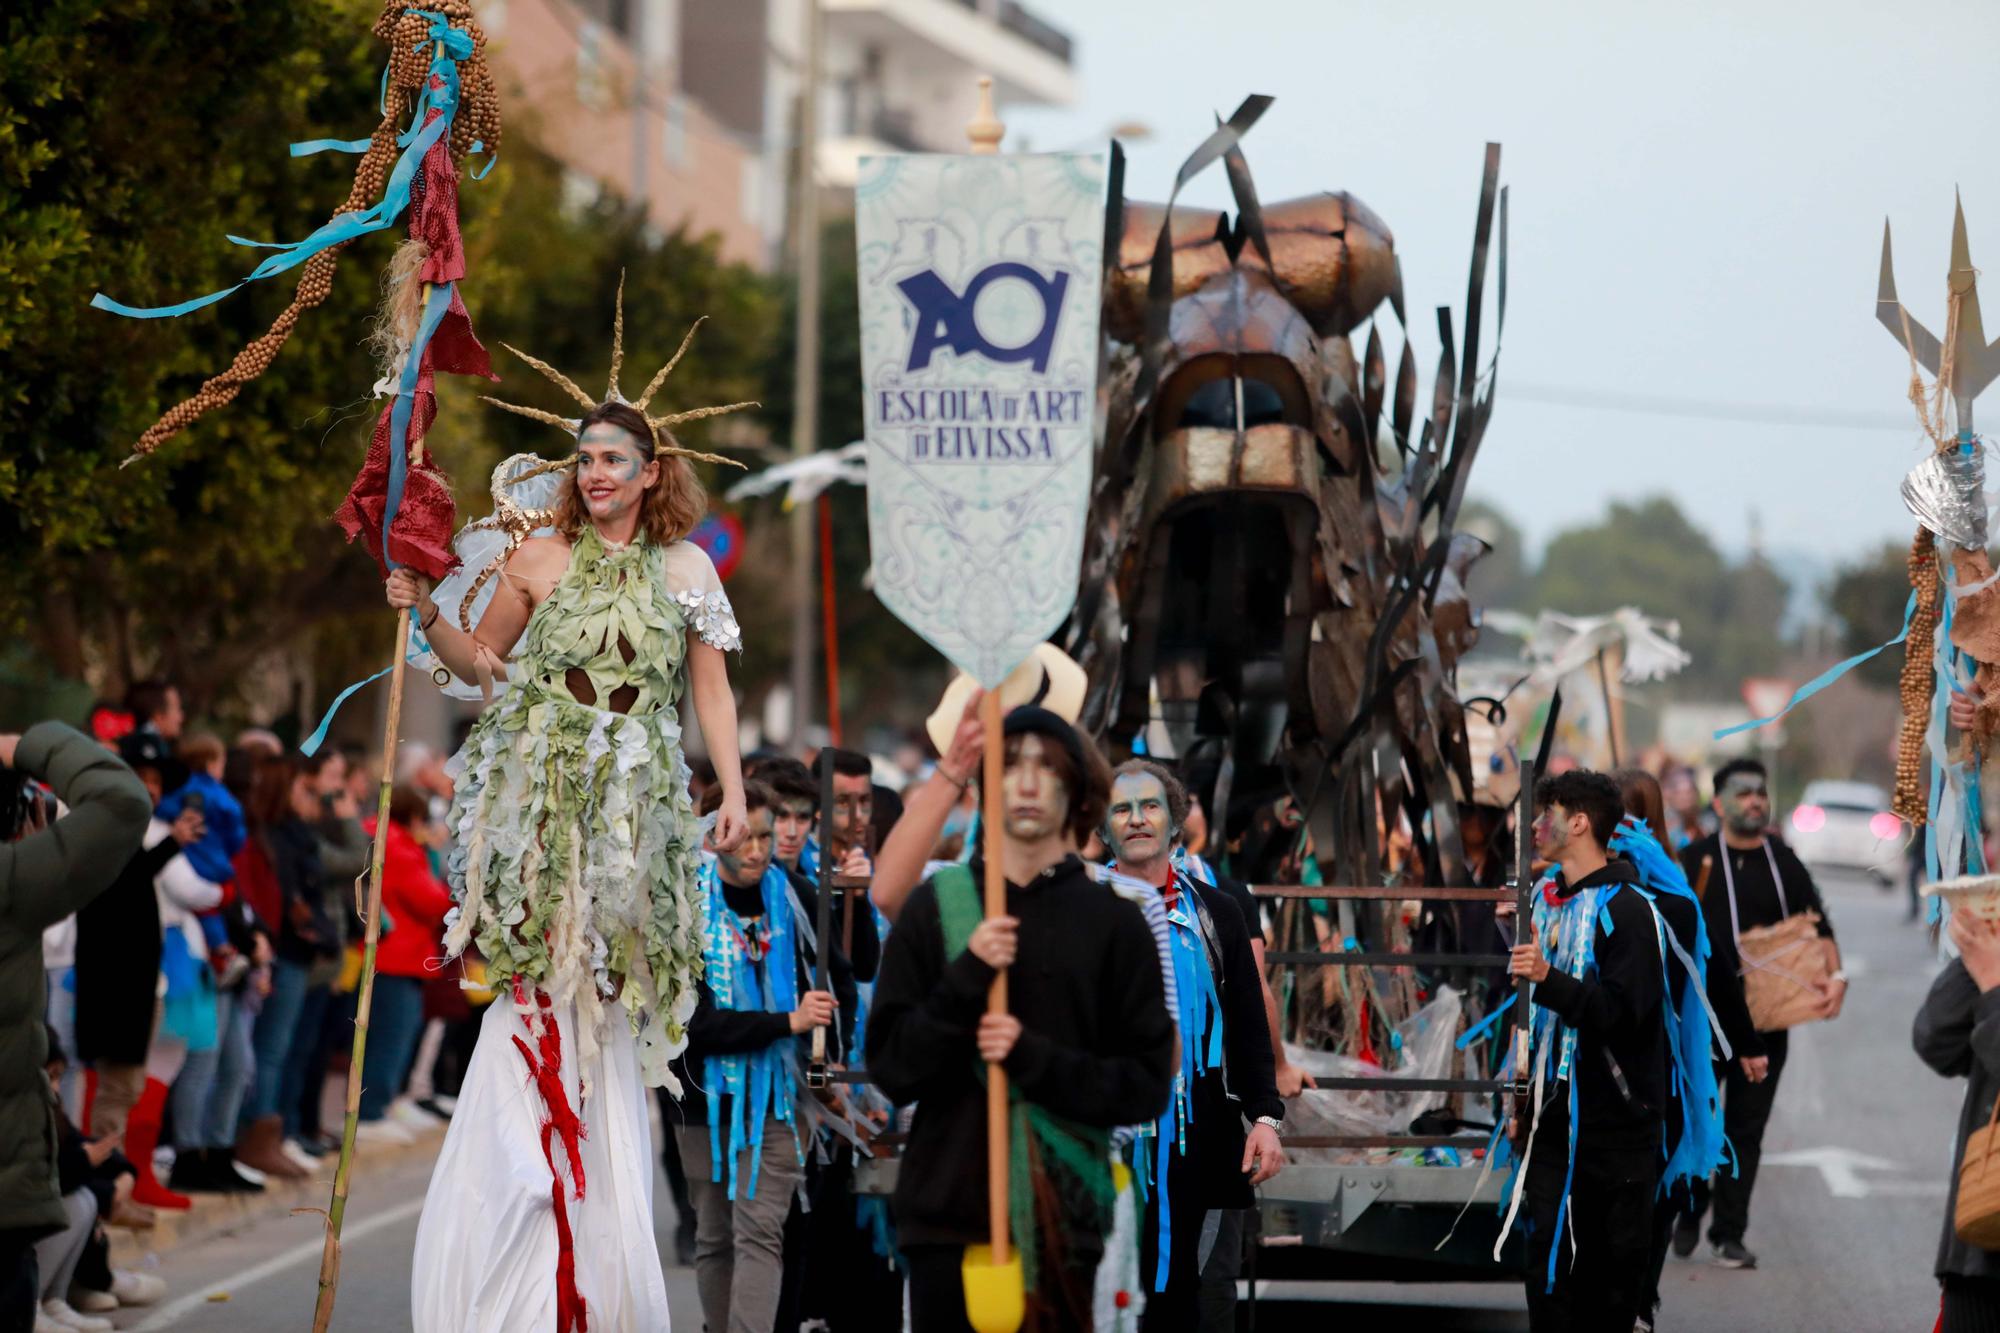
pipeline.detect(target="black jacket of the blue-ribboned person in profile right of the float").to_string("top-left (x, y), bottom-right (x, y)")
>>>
top-left (1534, 861), bottom-right (1668, 1155)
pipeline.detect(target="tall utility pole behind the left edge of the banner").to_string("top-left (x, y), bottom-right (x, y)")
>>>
top-left (790, 0), bottom-right (820, 749)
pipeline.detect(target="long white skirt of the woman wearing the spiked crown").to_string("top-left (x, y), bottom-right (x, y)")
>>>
top-left (410, 980), bottom-right (668, 1333)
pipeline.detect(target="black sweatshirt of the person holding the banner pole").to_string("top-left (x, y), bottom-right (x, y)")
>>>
top-left (868, 857), bottom-right (1176, 1245)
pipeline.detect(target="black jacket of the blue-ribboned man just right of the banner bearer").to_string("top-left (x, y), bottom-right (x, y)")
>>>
top-left (1188, 881), bottom-right (1284, 1209)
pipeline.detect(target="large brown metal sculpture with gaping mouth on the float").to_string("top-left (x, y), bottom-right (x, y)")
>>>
top-left (1068, 98), bottom-right (1506, 908)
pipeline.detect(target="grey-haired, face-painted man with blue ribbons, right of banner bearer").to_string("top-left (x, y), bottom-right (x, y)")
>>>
top-left (1104, 759), bottom-right (1284, 1333)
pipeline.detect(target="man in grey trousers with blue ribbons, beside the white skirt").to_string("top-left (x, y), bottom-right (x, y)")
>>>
top-left (668, 779), bottom-right (854, 1333)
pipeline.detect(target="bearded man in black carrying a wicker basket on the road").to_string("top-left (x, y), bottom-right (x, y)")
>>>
top-left (1674, 759), bottom-right (1848, 1269)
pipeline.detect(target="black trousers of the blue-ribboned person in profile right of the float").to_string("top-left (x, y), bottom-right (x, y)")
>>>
top-left (1524, 1143), bottom-right (1660, 1333)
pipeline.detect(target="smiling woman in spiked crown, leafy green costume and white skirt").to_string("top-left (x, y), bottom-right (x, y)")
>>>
top-left (388, 294), bottom-right (752, 1333)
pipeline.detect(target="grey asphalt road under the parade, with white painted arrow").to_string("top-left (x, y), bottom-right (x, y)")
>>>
top-left (118, 879), bottom-right (1962, 1333)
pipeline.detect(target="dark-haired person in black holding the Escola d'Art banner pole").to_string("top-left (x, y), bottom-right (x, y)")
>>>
top-left (868, 707), bottom-right (1176, 1333)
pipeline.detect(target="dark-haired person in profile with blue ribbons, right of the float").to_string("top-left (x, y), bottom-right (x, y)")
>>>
top-left (1500, 769), bottom-right (1668, 1333)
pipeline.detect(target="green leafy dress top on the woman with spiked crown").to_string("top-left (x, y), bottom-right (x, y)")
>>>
top-left (444, 526), bottom-right (742, 1093)
